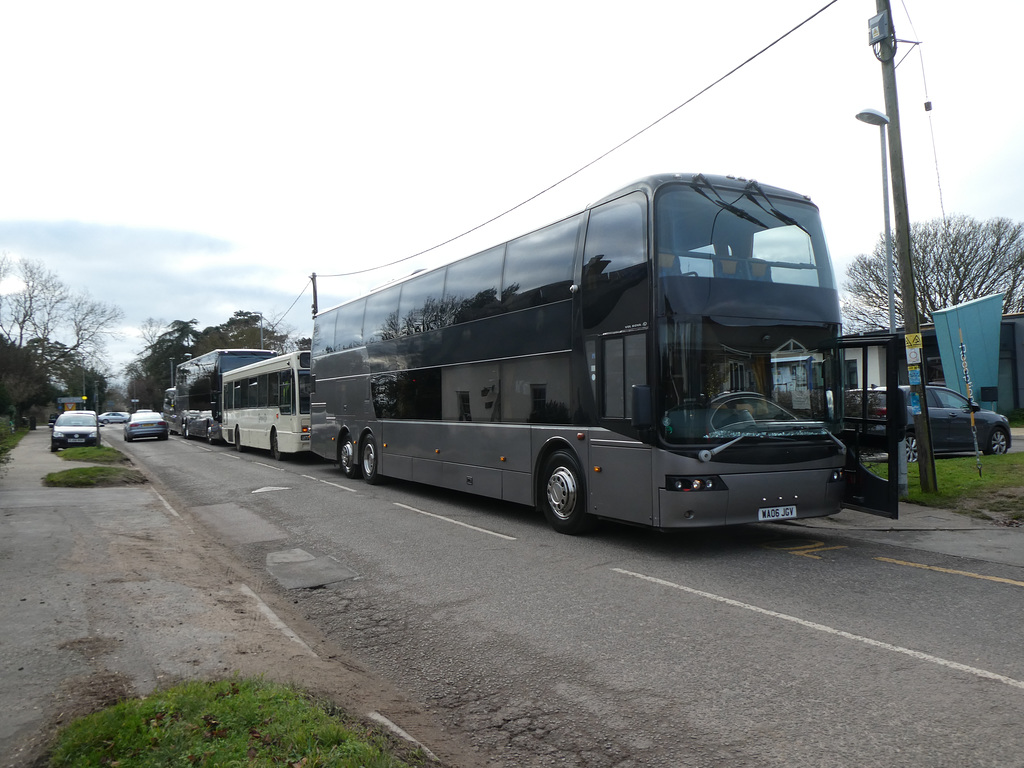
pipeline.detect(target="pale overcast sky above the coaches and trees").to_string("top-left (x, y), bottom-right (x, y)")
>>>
top-left (0, 0), bottom-right (1024, 380)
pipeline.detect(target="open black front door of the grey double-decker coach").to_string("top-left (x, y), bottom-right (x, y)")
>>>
top-left (839, 334), bottom-right (906, 520)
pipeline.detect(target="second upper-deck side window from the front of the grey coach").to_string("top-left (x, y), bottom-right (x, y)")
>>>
top-left (502, 216), bottom-right (582, 310)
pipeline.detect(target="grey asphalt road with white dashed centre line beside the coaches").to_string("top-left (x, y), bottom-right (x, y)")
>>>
top-left (105, 430), bottom-right (1024, 768)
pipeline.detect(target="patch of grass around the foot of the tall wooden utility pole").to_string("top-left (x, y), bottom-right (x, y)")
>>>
top-left (870, 454), bottom-right (1024, 520)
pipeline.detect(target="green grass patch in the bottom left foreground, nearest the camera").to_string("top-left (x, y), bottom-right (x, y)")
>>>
top-left (50, 679), bottom-right (426, 768)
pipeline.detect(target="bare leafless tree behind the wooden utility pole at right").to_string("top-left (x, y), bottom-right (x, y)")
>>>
top-left (843, 215), bottom-right (1024, 332)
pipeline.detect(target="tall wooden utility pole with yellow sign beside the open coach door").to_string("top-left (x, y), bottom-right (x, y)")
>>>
top-left (870, 0), bottom-right (938, 493)
